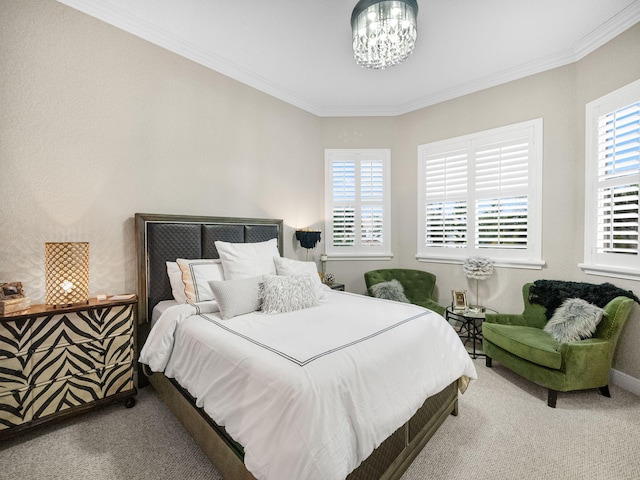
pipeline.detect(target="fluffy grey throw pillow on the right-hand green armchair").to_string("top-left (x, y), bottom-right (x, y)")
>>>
top-left (544, 298), bottom-right (604, 343)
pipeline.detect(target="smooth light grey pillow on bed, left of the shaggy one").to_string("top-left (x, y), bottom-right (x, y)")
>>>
top-left (209, 277), bottom-right (262, 320)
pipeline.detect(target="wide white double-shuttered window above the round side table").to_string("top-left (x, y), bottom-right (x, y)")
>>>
top-left (417, 119), bottom-right (544, 268)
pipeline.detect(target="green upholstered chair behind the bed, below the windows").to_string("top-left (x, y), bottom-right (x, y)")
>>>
top-left (364, 268), bottom-right (445, 315)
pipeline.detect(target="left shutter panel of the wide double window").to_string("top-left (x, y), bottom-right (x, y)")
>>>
top-left (424, 149), bottom-right (468, 248)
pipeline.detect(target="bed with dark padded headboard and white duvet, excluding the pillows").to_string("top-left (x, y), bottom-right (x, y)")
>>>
top-left (135, 214), bottom-right (476, 480)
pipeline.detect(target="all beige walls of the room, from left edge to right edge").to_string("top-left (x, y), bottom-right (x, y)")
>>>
top-left (0, 0), bottom-right (640, 379)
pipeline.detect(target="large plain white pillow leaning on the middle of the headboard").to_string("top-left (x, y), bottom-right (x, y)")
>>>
top-left (215, 238), bottom-right (280, 280)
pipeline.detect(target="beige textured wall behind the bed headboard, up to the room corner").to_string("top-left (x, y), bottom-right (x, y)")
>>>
top-left (0, 0), bottom-right (324, 302)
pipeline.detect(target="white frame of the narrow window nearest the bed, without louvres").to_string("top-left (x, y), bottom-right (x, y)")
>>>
top-left (325, 148), bottom-right (393, 260)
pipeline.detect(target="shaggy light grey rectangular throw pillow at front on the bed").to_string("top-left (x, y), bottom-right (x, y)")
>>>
top-left (260, 274), bottom-right (320, 314)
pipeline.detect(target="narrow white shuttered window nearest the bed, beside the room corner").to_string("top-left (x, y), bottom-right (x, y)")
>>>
top-left (325, 150), bottom-right (391, 258)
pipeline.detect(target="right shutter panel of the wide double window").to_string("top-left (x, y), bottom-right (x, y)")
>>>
top-left (475, 137), bottom-right (530, 249)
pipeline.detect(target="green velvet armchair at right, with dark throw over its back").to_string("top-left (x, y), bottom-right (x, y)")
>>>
top-left (482, 283), bottom-right (634, 408)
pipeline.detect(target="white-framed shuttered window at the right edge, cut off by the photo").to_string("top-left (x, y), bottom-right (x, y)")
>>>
top-left (580, 80), bottom-right (640, 279)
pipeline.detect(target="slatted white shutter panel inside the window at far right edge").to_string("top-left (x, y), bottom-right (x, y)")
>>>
top-left (596, 102), bottom-right (640, 255)
